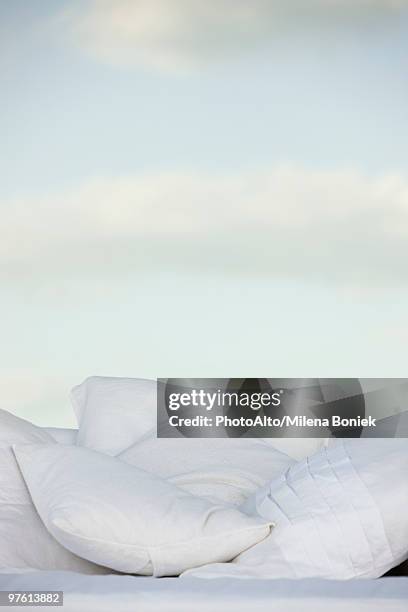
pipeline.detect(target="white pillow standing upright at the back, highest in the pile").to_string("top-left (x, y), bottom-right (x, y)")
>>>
top-left (71, 376), bottom-right (157, 455)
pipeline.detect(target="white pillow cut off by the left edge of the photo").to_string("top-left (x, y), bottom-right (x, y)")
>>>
top-left (0, 410), bottom-right (107, 573)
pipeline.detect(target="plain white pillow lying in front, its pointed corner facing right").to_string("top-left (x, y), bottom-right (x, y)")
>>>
top-left (14, 444), bottom-right (271, 576)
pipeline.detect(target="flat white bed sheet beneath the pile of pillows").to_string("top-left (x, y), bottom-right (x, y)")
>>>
top-left (0, 572), bottom-right (408, 612)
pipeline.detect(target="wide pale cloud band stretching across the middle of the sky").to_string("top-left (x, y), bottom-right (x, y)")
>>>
top-left (0, 165), bottom-right (408, 286)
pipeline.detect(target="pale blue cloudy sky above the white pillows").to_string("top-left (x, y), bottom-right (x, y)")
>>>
top-left (0, 0), bottom-right (408, 426)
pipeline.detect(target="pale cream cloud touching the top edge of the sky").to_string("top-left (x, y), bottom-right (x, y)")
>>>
top-left (59, 0), bottom-right (408, 72)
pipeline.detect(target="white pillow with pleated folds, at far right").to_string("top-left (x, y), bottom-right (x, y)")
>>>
top-left (186, 438), bottom-right (408, 579)
